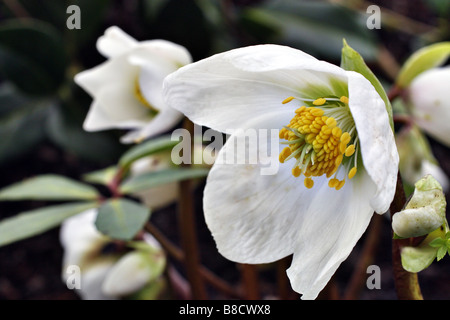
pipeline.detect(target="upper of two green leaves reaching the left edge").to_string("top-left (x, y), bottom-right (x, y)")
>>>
top-left (0, 174), bottom-right (99, 200)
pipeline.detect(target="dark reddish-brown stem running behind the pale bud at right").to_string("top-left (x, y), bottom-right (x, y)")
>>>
top-left (390, 174), bottom-right (423, 300)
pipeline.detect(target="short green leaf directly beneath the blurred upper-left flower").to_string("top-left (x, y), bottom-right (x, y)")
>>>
top-left (119, 136), bottom-right (179, 169)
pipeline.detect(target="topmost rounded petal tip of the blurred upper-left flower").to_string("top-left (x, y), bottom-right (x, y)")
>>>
top-left (97, 26), bottom-right (138, 58)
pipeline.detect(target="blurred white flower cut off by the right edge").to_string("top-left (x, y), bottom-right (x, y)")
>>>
top-left (408, 67), bottom-right (450, 146)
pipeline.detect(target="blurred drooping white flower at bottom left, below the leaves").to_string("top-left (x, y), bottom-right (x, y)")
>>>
top-left (60, 209), bottom-right (165, 300)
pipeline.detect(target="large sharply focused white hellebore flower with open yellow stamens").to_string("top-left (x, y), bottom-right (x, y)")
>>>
top-left (164, 45), bottom-right (398, 299)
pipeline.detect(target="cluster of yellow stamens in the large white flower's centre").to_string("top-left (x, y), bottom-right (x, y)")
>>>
top-left (279, 97), bottom-right (358, 190)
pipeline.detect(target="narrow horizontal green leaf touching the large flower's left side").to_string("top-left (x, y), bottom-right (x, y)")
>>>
top-left (120, 168), bottom-right (209, 194)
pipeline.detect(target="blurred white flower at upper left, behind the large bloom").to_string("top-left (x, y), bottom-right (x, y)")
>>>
top-left (75, 27), bottom-right (191, 143)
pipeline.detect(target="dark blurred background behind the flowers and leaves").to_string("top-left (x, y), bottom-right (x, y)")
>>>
top-left (0, 0), bottom-right (450, 300)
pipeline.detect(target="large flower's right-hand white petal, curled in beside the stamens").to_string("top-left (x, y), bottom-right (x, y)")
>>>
top-left (348, 71), bottom-right (399, 214)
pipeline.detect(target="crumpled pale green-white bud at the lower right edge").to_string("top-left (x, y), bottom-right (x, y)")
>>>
top-left (392, 175), bottom-right (446, 238)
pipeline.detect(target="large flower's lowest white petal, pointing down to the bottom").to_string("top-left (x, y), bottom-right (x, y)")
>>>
top-left (287, 173), bottom-right (375, 300)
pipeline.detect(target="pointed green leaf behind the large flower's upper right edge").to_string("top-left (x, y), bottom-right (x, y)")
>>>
top-left (341, 39), bottom-right (394, 129)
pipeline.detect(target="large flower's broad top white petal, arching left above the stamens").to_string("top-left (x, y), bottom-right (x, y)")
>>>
top-left (164, 45), bottom-right (346, 133)
